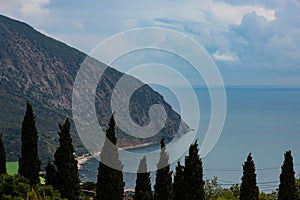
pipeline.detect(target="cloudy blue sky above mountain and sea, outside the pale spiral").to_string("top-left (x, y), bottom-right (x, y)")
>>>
top-left (0, 0), bottom-right (300, 87)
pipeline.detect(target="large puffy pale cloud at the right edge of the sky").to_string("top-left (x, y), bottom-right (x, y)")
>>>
top-left (226, 2), bottom-right (300, 72)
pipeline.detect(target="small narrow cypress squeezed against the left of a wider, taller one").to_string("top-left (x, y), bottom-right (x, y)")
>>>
top-left (173, 161), bottom-right (186, 200)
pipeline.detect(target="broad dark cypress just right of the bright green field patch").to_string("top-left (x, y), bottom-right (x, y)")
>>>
top-left (53, 119), bottom-right (80, 200)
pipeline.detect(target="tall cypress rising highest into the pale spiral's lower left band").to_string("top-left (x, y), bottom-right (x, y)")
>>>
top-left (96, 115), bottom-right (125, 200)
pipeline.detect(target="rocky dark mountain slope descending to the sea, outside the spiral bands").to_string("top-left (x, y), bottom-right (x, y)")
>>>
top-left (0, 15), bottom-right (188, 161)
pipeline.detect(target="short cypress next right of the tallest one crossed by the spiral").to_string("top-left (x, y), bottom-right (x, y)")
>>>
top-left (133, 156), bottom-right (152, 200)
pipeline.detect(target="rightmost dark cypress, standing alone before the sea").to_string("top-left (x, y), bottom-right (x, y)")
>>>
top-left (278, 151), bottom-right (297, 200)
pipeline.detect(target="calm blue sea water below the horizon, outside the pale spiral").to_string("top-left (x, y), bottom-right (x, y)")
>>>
top-left (80, 88), bottom-right (300, 192)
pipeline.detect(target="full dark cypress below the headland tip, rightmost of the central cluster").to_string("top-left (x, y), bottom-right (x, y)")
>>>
top-left (184, 141), bottom-right (205, 200)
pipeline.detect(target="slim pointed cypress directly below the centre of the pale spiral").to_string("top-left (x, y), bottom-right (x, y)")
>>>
top-left (154, 139), bottom-right (173, 200)
